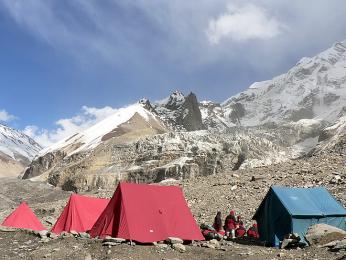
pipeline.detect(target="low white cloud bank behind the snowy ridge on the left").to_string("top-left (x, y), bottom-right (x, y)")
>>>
top-left (23, 106), bottom-right (117, 147)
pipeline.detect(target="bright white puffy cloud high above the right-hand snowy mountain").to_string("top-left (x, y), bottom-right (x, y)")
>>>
top-left (206, 4), bottom-right (285, 44)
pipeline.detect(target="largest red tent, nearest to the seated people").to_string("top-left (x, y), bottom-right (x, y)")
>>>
top-left (90, 183), bottom-right (204, 243)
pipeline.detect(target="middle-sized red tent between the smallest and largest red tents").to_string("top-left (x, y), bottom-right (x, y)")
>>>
top-left (52, 194), bottom-right (109, 234)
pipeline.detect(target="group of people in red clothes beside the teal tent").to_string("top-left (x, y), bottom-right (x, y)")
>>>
top-left (204, 210), bottom-right (259, 239)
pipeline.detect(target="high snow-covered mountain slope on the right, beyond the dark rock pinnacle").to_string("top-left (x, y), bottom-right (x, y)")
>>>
top-left (203, 41), bottom-right (346, 126)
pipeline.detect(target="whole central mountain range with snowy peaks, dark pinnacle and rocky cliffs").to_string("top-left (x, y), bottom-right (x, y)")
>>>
top-left (23, 41), bottom-right (346, 190)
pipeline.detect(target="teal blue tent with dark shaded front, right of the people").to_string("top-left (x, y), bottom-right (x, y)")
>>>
top-left (253, 186), bottom-right (346, 246)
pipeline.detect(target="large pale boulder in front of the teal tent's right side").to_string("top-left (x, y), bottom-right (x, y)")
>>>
top-left (305, 224), bottom-right (346, 245)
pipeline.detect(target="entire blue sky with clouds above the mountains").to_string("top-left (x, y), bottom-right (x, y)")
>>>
top-left (0, 0), bottom-right (346, 146)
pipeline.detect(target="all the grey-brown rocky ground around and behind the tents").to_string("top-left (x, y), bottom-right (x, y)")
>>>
top-left (0, 153), bottom-right (346, 259)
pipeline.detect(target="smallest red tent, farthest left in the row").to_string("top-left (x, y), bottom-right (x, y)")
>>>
top-left (1, 202), bottom-right (46, 231)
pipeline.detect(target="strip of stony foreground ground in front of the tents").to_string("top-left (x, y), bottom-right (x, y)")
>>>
top-left (0, 231), bottom-right (343, 260)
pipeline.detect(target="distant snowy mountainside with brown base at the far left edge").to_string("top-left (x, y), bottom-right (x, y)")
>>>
top-left (0, 124), bottom-right (42, 177)
